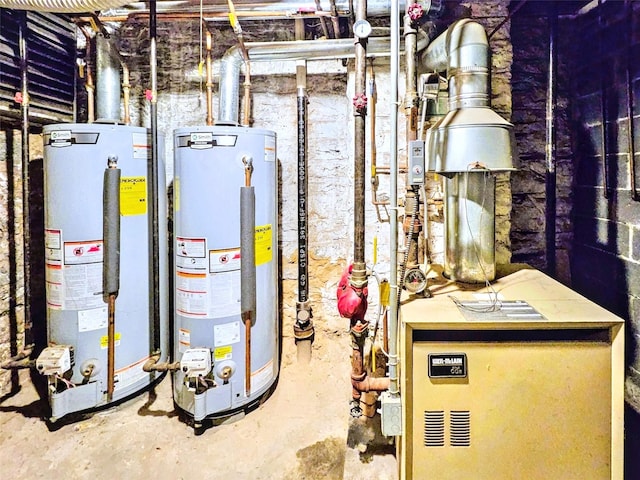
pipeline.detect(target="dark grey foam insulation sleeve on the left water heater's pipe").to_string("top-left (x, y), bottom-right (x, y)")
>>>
top-left (102, 163), bottom-right (120, 295)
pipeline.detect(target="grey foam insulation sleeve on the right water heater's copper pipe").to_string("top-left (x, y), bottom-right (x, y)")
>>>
top-left (240, 187), bottom-right (256, 324)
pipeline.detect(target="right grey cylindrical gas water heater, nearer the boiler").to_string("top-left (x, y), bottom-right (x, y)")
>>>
top-left (173, 126), bottom-right (279, 422)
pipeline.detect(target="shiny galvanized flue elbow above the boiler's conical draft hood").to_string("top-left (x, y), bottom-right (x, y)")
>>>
top-left (421, 19), bottom-right (490, 110)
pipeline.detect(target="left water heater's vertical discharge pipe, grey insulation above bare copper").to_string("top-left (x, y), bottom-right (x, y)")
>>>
top-left (102, 156), bottom-right (120, 402)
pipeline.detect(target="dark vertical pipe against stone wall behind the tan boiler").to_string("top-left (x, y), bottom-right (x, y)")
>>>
top-left (545, 2), bottom-right (558, 276)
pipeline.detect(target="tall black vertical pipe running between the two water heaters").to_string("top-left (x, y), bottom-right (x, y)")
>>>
top-left (147, 0), bottom-right (160, 352)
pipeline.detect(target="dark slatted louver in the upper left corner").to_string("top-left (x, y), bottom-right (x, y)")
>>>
top-left (0, 8), bottom-right (76, 125)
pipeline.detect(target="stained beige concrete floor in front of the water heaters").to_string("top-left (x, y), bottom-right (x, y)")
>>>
top-left (0, 330), bottom-right (397, 480)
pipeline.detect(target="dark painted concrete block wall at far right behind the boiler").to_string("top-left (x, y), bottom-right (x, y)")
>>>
top-left (565, 1), bottom-right (640, 410)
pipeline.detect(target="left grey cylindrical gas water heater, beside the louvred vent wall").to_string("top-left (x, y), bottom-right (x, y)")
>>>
top-left (36, 123), bottom-right (169, 419)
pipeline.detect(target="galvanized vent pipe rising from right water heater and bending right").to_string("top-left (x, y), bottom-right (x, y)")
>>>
top-left (216, 35), bottom-right (429, 125)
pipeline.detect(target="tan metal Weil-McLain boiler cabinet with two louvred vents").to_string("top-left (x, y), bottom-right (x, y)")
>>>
top-left (398, 268), bottom-right (624, 480)
